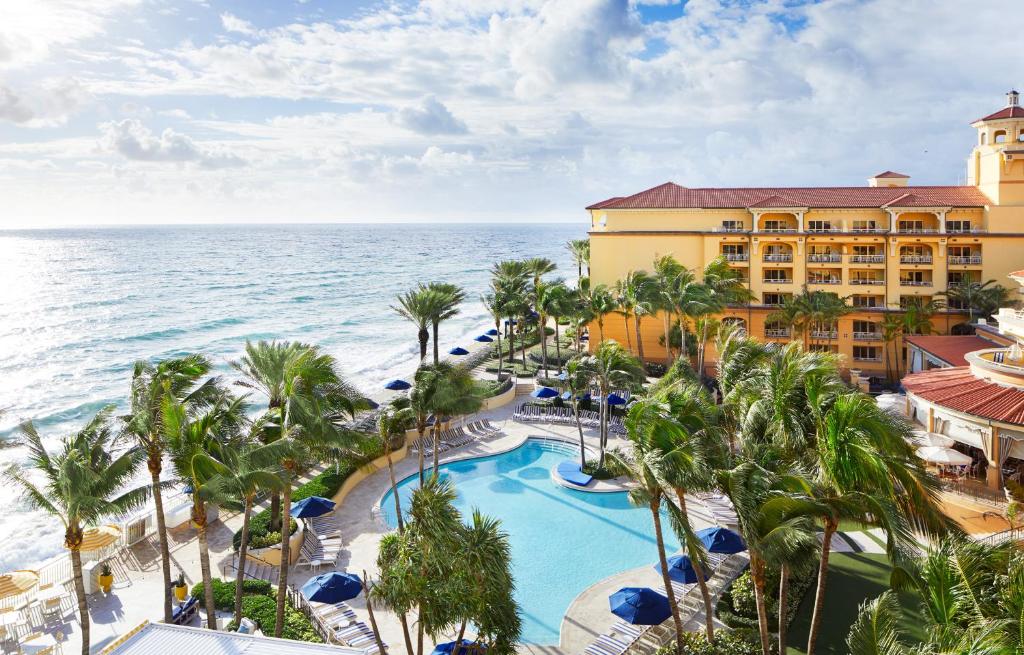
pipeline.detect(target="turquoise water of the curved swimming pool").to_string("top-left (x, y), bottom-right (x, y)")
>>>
top-left (381, 439), bottom-right (679, 646)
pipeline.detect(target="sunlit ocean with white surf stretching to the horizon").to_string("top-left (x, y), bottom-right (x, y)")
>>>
top-left (0, 222), bottom-right (587, 571)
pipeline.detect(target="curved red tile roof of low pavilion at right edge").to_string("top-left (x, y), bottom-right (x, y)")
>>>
top-left (903, 366), bottom-right (1024, 425)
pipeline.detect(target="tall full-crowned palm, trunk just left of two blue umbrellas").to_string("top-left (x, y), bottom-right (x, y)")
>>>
top-left (233, 341), bottom-right (368, 637)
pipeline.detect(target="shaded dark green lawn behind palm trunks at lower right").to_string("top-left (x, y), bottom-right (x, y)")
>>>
top-left (786, 553), bottom-right (924, 655)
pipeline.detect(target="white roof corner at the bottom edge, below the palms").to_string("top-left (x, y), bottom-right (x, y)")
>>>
top-left (101, 623), bottom-right (362, 655)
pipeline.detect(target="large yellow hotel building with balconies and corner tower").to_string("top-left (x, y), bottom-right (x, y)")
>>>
top-left (587, 91), bottom-right (1024, 376)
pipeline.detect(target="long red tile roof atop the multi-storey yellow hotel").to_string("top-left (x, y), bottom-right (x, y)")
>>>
top-left (587, 182), bottom-right (991, 209)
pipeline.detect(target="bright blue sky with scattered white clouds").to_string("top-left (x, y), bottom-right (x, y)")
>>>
top-left (0, 0), bottom-right (1024, 228)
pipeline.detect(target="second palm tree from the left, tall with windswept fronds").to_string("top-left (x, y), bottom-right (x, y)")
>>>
top-left (121, 355), bottom-right (220, 622)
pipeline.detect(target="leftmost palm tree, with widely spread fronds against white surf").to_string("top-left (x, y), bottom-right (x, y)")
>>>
top-left (3, 407), bottom-right (152, 655)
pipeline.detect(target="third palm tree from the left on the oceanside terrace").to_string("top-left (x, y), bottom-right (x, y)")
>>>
top-left (163, 388), bottom-right (245, 630)
